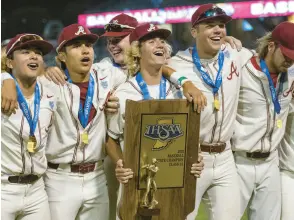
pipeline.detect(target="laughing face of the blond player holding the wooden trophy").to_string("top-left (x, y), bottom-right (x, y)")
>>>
top-left (140, 37), bottom-right (167, 68)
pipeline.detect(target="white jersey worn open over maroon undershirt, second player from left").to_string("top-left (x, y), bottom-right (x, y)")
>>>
top-left (42, 63), bottom-right (126, 163)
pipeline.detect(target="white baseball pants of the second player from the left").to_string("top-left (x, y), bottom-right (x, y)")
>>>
top-left (44, 164), bottom-right (109, 220)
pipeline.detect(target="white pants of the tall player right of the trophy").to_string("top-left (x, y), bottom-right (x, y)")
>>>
top-left (187, 150), bottom-right (240, 220)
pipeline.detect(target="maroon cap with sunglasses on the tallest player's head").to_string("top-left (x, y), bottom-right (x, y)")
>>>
top-left (191, 3), bottom-right (232, 27)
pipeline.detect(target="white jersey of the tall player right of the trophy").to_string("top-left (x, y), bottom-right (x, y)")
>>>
top-left (169, 45), bottom-right (253, 149)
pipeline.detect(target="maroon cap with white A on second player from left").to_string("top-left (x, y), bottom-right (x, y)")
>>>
top-left (56, 24), bottom-right (99, 53)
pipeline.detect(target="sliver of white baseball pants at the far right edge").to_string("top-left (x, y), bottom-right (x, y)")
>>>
top-left (280, 170), bottom-right (294, 220)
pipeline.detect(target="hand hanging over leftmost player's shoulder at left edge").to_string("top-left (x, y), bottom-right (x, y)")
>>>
top-left (1, 79), bottom-right (18, 116)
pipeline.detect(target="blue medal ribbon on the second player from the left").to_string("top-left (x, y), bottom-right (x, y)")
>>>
top-left (65, 70), bottom-right (95, 128)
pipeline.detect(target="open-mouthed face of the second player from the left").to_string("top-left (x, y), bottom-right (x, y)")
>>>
top-left (58, 39), bottom-right (94, 75)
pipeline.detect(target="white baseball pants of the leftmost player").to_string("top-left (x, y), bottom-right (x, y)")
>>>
top-left (1, 178), bottom-right (51, 220)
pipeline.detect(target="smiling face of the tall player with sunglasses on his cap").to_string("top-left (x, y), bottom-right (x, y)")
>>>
top-left (191, 20), bottom-right (227, 53)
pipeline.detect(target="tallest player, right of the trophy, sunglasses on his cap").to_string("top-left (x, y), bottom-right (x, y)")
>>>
top-left (165, 4), bottom-right (253, 220)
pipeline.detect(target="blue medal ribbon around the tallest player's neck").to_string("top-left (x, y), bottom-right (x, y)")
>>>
top-left (192, 45), bottom-right (224, 95)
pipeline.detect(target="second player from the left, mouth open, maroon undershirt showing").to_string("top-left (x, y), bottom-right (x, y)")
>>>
top-left (1, 24), bottom-right (127, 220)
